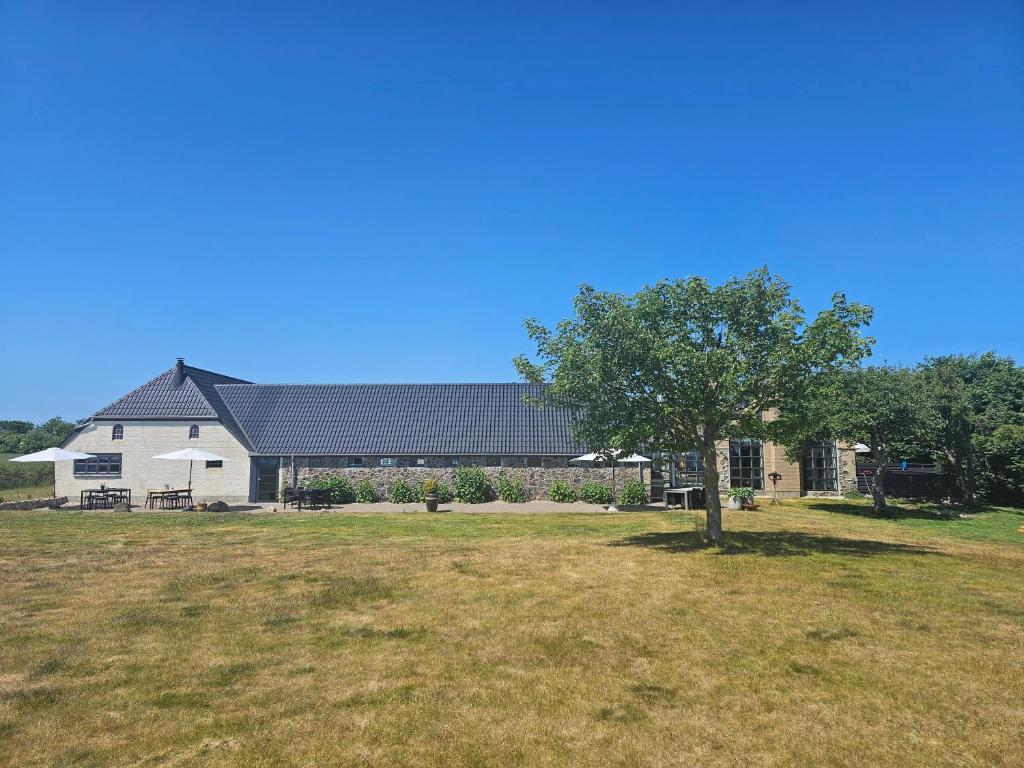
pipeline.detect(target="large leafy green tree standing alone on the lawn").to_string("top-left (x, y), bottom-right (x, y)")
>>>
top-left (515, 268), bottom-right (871, 543)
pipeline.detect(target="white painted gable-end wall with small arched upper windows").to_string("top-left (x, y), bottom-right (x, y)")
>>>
top-left (54, 421), bottom-right (249, 505)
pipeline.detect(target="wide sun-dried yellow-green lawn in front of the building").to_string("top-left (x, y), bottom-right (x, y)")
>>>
top-left (0, 501), bottom-right (1024, 766)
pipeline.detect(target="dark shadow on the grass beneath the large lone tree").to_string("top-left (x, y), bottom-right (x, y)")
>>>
top-left (609, 530), bottom-right (941, 557)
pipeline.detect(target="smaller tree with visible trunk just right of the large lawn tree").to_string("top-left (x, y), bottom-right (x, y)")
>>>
top-left (781, 366), bottom-right (936, 512)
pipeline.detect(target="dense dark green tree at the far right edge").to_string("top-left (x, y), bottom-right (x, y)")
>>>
top-left (921, 352), bottom-right (1024, 504)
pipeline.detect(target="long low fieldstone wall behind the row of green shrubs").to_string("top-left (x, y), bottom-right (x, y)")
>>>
top-left (281, 457), bottom-right (622, 499)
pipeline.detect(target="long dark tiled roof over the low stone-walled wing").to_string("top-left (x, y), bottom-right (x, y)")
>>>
top-left (216, 384), bottom-right (583, 456)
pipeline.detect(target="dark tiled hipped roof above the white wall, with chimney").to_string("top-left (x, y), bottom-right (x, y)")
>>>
top-left (92, 366), bottom-right (247, 448)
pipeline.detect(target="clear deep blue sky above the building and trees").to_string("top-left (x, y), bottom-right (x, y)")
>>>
top-left (0, 0), bottom-right (1024, 420)
